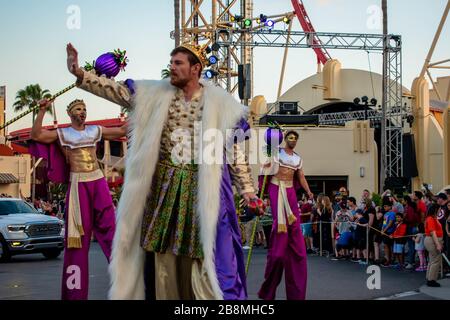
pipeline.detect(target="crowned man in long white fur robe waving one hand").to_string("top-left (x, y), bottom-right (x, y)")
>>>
top-left (67, 44), bottom-right (256, 299)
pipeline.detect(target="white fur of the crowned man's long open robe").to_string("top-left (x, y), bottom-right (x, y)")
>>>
top-left (109, 80), bottom-right (247, 299)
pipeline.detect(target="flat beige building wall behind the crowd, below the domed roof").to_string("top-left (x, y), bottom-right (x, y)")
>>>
top-left (252, 121), bottom-right (378, 197)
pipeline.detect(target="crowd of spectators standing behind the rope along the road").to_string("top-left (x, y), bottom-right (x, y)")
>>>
top-left (240, 187), bottom-right (450, 287)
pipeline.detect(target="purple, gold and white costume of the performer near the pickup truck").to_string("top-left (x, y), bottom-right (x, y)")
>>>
top-left (30, 107), bottom-right (115, 300)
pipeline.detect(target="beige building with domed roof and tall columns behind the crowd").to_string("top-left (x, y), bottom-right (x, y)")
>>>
top-left (252, 60), bottom-right (450, 197)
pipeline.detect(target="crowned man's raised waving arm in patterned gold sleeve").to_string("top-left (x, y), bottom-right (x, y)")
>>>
top-left (66, 43), bottom-right (133, 109)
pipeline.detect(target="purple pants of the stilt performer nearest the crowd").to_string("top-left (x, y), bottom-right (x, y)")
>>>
top-left (258, 183), bottom-right (307, 300)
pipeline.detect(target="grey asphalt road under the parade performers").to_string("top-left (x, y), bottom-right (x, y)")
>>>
top-left (0, 242), bottom-right (450, 300)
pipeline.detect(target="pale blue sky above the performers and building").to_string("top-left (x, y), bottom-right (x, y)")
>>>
top-left (0, 0), bottom-right (450, 131)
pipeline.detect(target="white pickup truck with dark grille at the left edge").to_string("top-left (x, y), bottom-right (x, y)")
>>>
top-left (0, 198), bottom-right (64, 261)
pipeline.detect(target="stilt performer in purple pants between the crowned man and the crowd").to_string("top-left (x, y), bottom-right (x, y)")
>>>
top-left (258, 130), bottom-right (313, 300)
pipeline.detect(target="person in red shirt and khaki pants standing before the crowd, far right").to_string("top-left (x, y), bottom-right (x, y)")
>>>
top-left (425, 204), bottom-right (444, 287)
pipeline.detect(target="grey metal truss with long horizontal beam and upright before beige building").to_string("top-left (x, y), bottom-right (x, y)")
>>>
top-left (214, 27), bottom-right (406, 177)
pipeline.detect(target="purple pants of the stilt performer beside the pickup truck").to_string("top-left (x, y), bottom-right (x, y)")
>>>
top-left (61, 178), bottom-right (116, 300)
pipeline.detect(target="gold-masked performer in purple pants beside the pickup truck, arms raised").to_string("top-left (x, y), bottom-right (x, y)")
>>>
top-left (31, 99), bottom-right (127, 300)
